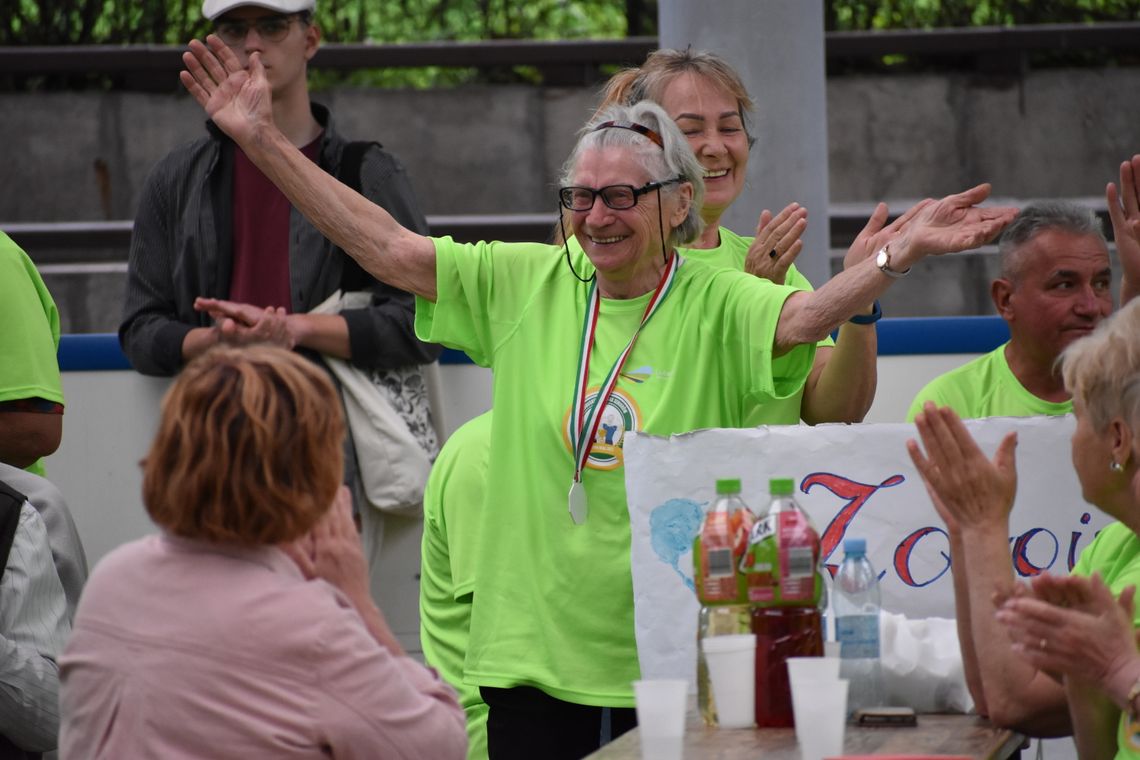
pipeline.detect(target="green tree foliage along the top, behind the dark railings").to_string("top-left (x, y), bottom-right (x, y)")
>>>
top-left (0, 0), bottom-right (1140, 88)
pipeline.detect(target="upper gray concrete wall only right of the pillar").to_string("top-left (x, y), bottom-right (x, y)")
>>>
top-left (828, 68), bottom-right (1140, 202)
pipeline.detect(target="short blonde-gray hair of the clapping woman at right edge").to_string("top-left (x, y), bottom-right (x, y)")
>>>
top-left (1059, 299), bottom-right (1140, 440)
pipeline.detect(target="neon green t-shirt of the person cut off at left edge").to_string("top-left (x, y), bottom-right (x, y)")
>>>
top-left (0, 232), bottom-right (64, 475)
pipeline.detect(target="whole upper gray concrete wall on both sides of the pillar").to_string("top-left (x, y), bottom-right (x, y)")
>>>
top-left (0, 68), bottom-right (1140, 222)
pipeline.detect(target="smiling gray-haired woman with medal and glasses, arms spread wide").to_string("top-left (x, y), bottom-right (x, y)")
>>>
top-left (181, 36), bottom-right (1013, 759)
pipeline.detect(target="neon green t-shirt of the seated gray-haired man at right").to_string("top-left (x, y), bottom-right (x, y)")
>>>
top-left (906, 343), bottom-right (1073, 422)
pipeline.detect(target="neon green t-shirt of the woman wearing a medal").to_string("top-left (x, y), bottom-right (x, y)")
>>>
top-left (416, 238), bottom-right (815, 706)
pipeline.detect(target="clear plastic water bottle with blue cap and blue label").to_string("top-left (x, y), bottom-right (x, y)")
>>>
top-left (831, 538), bottom-right (885, 714)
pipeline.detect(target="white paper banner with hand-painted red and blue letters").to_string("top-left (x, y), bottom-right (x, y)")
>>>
top-left (622, 416), bottom-right (1109, 679)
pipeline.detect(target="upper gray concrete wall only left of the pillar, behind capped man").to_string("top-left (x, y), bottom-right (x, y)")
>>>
top-left (0, 87), bottom-right (593, 222)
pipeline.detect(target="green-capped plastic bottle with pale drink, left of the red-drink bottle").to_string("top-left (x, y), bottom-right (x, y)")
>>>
top-left (693, 479), bottom-right (756, 726)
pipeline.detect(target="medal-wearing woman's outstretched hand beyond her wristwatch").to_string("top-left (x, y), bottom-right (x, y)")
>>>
top-left (891, 182), bottom-right (1017, 270)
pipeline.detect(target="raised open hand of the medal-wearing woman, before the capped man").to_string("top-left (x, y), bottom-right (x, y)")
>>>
top-left (178, 34), bottom-right (272, 145)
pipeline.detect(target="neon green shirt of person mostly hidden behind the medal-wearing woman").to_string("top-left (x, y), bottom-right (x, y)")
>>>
top-left (420, 411), bottom-right (491, 760)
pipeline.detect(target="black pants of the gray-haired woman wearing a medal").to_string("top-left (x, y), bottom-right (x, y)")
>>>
top-left (479, 686), bottom-right (637, 760)
